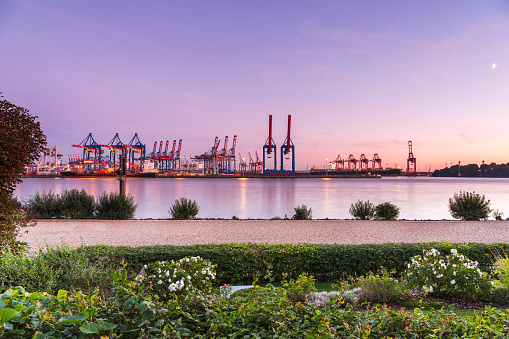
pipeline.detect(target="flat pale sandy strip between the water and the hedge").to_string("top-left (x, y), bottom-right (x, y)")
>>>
top-left (20, 220), bottom-right (509, 250)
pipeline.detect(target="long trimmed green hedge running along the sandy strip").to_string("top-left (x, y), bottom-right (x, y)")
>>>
top-left (74, 242), bottom-right (509, 284)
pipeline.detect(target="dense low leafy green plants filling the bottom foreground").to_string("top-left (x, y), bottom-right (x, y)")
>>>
top-left (0, 254), bottom-right (509, 338)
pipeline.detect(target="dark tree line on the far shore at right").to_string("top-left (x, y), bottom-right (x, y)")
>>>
top-left (432, 162), bottom-right (509, 178)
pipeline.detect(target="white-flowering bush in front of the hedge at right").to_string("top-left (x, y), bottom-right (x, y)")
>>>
top-left (406, 248), bottom-right (493, 296)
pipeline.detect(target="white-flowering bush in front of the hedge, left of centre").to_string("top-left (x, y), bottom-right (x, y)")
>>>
top-left (135, 257), bottom-right (216, 300)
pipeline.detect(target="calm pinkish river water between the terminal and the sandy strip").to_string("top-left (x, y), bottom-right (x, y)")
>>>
top-left (15, 177), bottom-right (509, 220)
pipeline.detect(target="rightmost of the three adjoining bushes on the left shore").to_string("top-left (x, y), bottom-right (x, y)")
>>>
top-left (96, 192), bottom-right (138, 220)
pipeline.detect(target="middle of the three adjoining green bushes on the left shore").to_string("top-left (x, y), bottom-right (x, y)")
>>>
top-left (60, 188), bottom-right (95, 219)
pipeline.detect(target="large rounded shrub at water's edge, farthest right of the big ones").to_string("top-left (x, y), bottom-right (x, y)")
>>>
top-left (449, 191), bottom-right (491, 220)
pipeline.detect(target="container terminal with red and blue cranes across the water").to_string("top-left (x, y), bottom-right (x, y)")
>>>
top-left (23, 115), bottom-right (429, 178)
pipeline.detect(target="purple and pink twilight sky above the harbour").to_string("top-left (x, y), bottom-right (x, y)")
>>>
top-left (0, 0), bottom-right (509, 171)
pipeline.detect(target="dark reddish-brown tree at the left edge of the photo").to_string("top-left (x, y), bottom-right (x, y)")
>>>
top-left (0, 93), bottom-right (46, 249)
